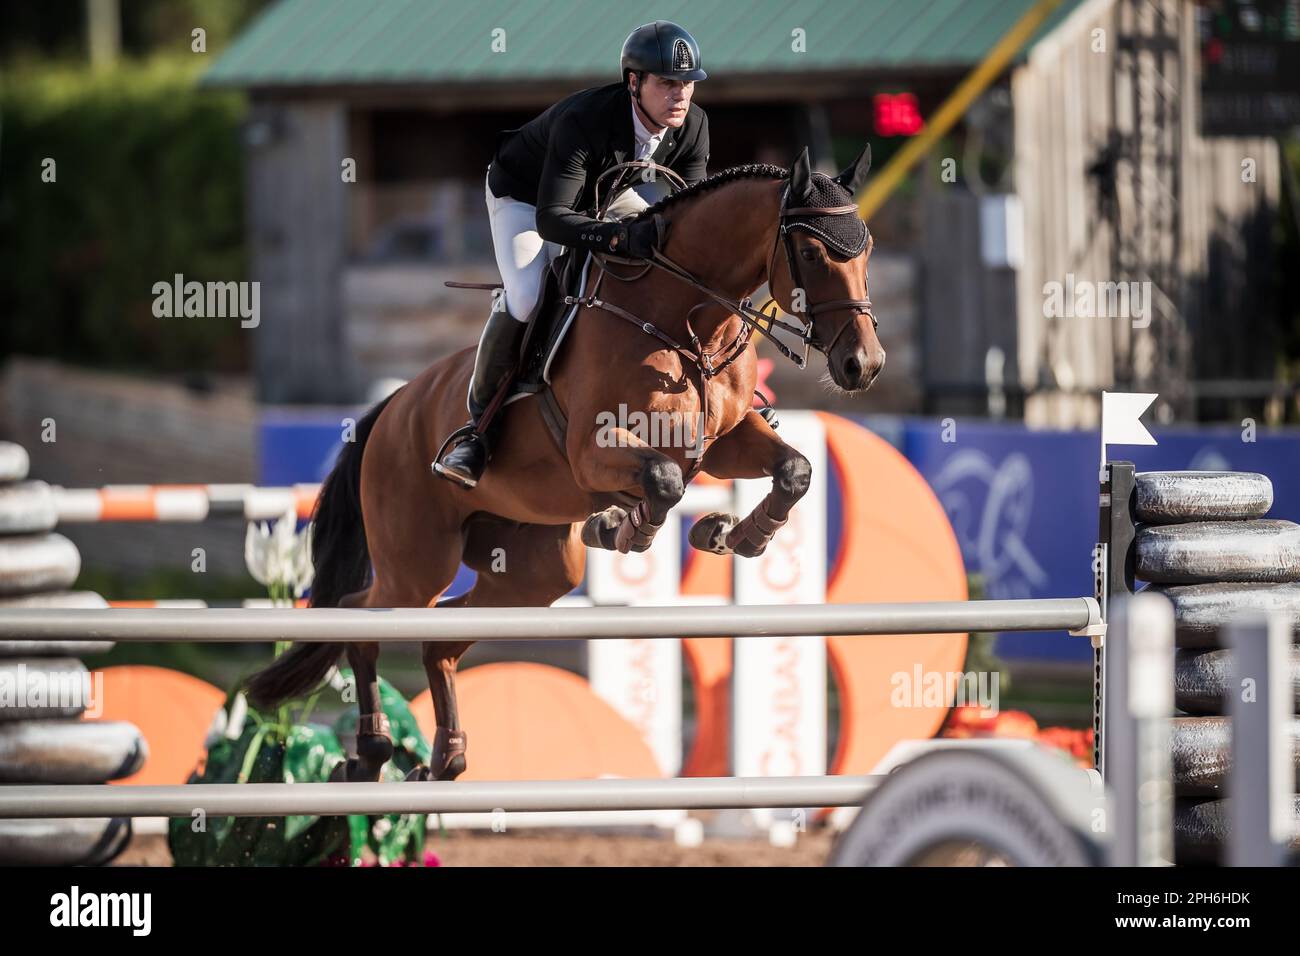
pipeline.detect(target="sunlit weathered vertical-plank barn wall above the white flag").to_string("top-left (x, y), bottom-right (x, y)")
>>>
top-left (1011, 0), bottom-right (1279, 427)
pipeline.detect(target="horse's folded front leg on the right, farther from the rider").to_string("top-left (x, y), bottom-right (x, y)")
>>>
top-left (690, 411), bottom-right (813, 558)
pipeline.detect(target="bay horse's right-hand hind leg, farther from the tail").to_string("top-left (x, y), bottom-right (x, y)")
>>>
top-left (408, 516), bottom-right (586, 780)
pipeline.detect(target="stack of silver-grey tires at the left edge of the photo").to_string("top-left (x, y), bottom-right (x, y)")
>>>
top-left (0, 442), bottom-right (148, 866)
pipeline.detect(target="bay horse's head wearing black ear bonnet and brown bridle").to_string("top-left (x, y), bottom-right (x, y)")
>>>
top-left (768, 146), bottom-right (885, 392)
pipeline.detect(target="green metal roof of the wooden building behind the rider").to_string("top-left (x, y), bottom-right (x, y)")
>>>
top-left (204, 0), bottom-right (1079, 87)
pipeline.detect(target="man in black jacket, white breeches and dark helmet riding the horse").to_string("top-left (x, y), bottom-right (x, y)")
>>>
top-left (433, 20), bottom-right (709, 488)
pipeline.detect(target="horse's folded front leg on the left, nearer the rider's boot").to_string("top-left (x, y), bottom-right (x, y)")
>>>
top-left (571, 428), bottom-right (686, 554)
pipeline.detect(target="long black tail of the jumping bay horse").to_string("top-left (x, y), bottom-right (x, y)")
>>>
top-left (244, 393), bottom-right (397, 708)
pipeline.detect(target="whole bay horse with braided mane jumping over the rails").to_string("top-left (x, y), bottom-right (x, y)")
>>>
top-left (247, 147), bottom-right (885, 782)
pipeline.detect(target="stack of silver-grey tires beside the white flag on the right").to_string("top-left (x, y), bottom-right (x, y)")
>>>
top-left (1134, 471), bottom-right (1300, 864)
